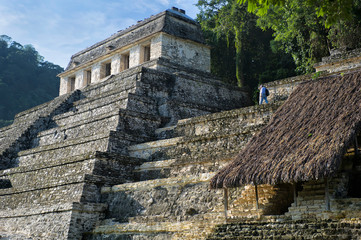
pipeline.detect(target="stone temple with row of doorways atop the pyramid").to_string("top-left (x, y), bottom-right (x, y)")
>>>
top-left (59, 7), bottom-right (210, 95)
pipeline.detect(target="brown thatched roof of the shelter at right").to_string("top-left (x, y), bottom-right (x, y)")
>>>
top-left (211, 71), bottom-right (361, 188)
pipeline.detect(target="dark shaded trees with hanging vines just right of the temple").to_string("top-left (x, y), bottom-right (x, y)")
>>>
top-left (197, 0), bottom-right (295, 99)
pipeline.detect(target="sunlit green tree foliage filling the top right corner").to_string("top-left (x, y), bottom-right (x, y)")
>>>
top-left (239, 0), bottom-right (361, 73)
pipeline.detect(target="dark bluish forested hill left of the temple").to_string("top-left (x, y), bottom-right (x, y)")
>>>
top-left (0, 35), bottom-right (63, 127)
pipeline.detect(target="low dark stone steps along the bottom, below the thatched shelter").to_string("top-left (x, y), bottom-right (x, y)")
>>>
top-left (206, 220), bottom-right (361, 240)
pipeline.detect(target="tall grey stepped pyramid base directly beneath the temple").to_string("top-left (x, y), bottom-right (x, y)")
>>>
top-left (0, 64), bottom-right (250, 239)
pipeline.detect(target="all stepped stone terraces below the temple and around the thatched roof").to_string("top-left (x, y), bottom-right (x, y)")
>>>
top-left (0, 55), bottom-right (359, 240)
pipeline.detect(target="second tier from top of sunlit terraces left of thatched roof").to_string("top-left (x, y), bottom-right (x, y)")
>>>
top-left (128, 122), bottom-right (261, 164)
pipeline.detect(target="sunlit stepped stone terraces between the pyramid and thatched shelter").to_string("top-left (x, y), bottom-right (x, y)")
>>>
top-left (85, 103), bottom-right (281, 239)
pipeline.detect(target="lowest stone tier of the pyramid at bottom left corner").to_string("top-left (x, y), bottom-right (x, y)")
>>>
top-left (0, 202), bottom-right (106, 240)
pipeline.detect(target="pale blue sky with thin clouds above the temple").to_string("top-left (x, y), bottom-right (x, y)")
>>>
top-left (0, 0), bottom-right (198, 67)
